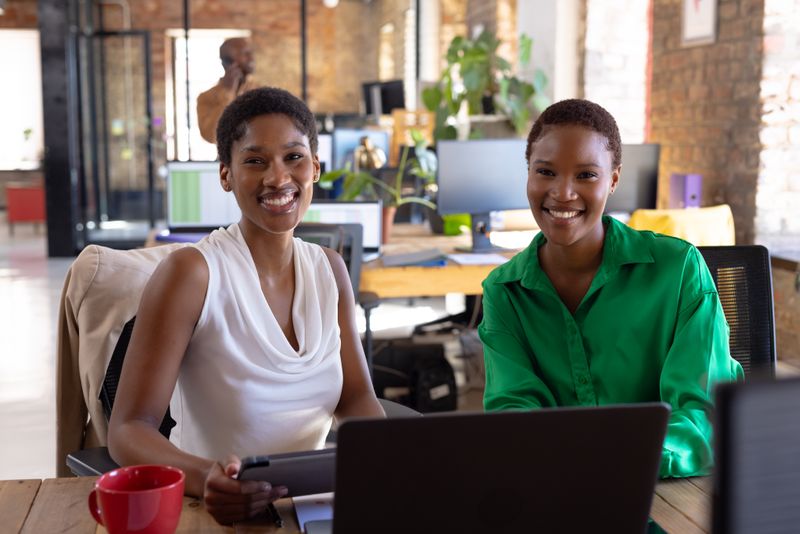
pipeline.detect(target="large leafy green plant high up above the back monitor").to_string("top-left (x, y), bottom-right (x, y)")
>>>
top-left (422, 30), bottom-right (548, 140)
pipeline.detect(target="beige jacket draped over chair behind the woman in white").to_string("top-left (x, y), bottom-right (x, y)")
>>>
top-left (56, 244), bottom-right (186, 477)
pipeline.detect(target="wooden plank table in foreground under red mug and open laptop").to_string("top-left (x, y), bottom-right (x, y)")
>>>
top-left (0, 477), bottom-right (711, 534)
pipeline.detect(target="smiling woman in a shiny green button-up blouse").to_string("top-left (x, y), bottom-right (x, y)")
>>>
top-left (479, 100), bottom-right (743, 477)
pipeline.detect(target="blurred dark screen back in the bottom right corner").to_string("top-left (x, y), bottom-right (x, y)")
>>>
top-left (712, 378), bottom-right (800, 534)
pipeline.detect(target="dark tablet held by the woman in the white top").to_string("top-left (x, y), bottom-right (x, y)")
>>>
top-left (239, 449), bottom-right (336, 497)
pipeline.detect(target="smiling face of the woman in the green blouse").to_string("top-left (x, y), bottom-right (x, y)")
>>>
top-left (528, 124), bottom-right (619, 251)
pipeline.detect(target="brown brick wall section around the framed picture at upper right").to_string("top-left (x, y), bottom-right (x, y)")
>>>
top-left (651, 0), bottom-right (764, 243)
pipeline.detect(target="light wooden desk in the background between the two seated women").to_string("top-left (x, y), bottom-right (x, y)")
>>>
top-left (360, 224), bottom-right (516, 298)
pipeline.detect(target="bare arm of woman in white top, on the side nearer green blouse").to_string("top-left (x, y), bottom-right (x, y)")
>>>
top-left (324, 249), bottom-right (385, 426)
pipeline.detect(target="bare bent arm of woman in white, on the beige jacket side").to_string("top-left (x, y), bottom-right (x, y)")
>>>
top-left (108, 248), bottom-right (214, 495)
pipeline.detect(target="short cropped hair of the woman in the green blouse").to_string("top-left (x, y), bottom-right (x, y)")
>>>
top-left (525, 98), bottom-right (622, 169)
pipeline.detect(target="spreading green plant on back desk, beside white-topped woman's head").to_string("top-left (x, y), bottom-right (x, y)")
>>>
top-left (319, 130), bottom-right (437, 242)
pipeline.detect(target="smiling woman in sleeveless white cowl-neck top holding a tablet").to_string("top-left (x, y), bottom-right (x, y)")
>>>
top-left (108, 88), bottom-right (383, 523)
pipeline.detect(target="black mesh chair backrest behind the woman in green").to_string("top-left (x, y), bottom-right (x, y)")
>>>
top-left (698, 245), bottom-right (776, 379)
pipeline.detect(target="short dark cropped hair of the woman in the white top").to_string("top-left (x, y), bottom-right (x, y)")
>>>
top-left (217, 87), bottom-right (318, 165)
